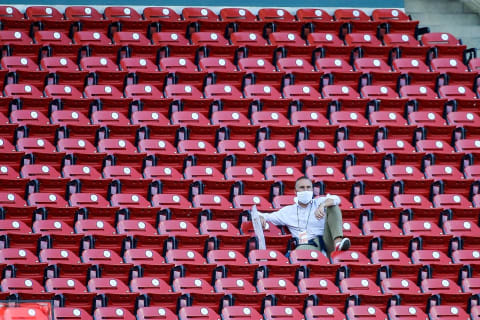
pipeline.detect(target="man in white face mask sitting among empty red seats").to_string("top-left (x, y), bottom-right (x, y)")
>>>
top-left (259, 177), bottom-right (350, 255)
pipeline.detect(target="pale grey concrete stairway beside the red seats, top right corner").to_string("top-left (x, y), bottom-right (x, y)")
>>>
top-left (405, 0), bottom-right (480, 49)
